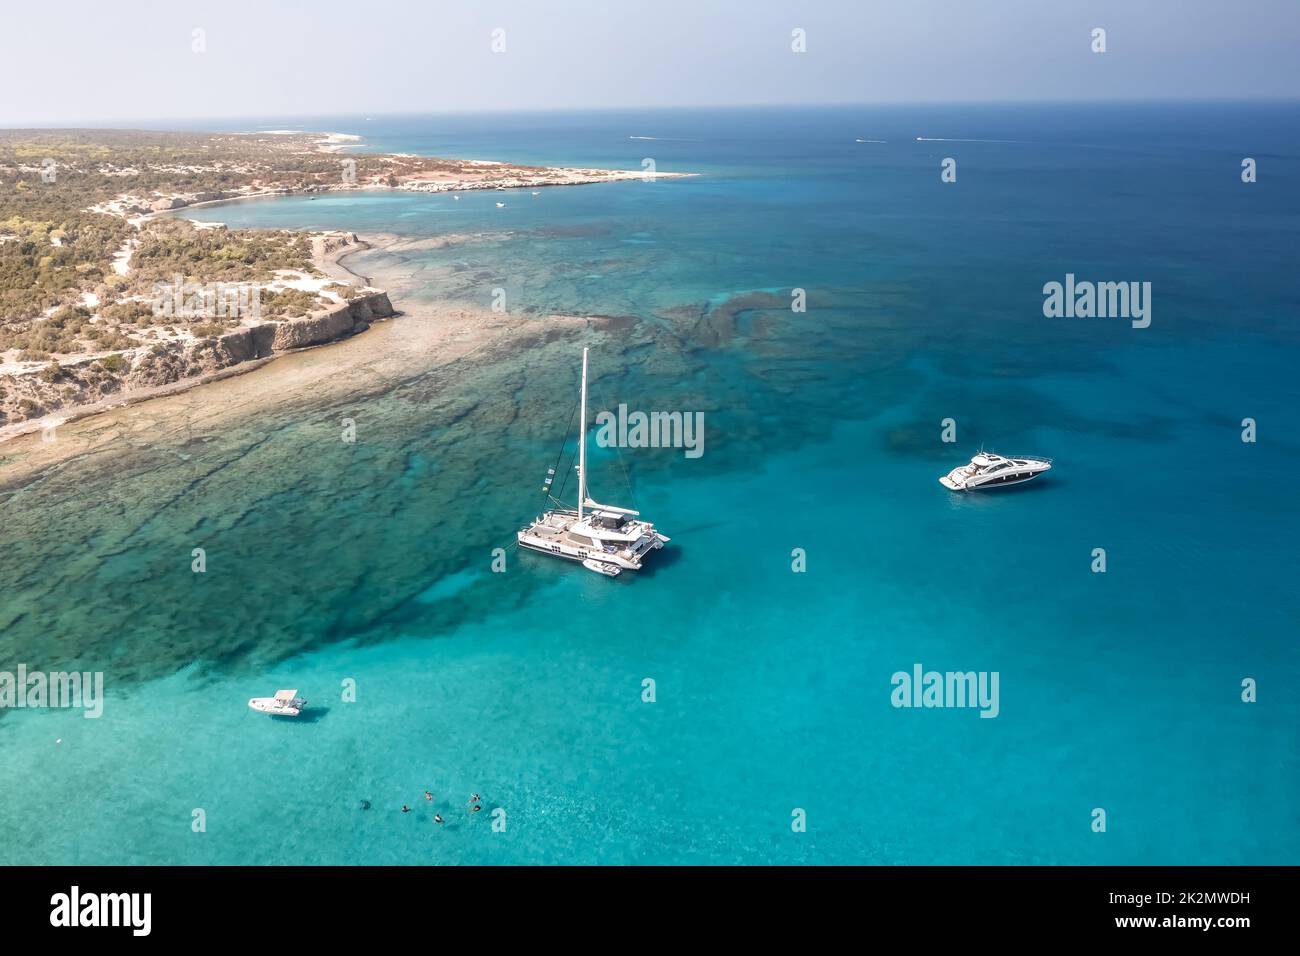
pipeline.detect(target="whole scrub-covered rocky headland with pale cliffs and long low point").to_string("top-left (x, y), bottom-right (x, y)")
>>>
top-left (0, 130), bottom-right (569, 427)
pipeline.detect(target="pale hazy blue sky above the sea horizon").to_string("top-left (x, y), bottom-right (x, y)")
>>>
top-left (0, 0), bottom-right (1300, 126)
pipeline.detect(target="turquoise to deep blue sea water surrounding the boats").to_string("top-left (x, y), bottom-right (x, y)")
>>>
top-left (0, 104), bottom-right (1300, 864)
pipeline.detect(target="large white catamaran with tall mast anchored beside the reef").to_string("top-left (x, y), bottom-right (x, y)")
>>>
top-left (517, 349), bottom-right (668, 578)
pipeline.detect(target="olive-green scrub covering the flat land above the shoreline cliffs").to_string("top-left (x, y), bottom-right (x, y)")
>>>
top-left (0, 130), bottom-right (356, 327)
